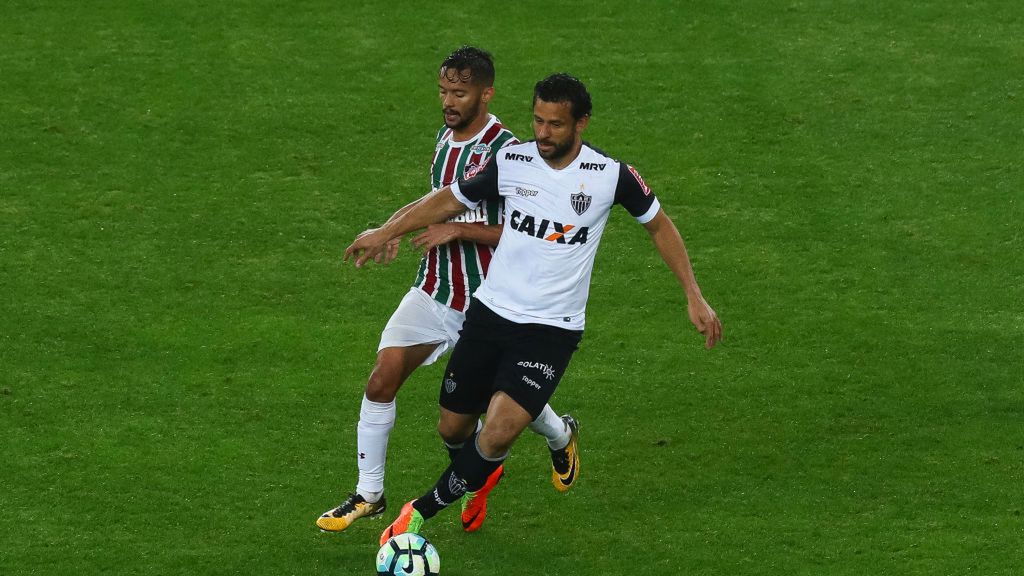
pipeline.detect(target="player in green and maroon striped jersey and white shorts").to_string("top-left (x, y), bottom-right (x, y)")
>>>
top-left (316, 46), bottom-right (579, 532)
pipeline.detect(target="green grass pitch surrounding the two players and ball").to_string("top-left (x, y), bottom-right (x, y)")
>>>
top-left (0, 0), bottom-right (1024, 576)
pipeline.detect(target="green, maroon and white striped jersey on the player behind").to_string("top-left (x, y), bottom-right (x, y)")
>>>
top-left (415, 116), bottom-right (518, 312)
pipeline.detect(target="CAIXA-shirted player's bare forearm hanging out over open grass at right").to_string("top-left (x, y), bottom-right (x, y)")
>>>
top-left (644, 209), bottom-right (722, 348)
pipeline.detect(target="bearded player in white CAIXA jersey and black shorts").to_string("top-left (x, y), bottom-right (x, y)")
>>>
top-left (345, 74), bottom-right (722, 541)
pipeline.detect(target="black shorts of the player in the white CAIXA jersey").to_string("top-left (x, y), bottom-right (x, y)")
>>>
top-left (440, 300), bottom-right (583, 419)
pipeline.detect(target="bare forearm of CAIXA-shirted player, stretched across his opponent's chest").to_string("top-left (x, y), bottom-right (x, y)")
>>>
top-left (345, 187), bottom-right (466, 268)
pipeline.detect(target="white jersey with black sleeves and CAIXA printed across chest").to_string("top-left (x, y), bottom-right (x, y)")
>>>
top-left (452, 141), bottom-right (660, 330)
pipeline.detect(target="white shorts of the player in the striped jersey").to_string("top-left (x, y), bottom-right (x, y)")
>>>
top-left (377, 287), bottom-right (466, 366)
